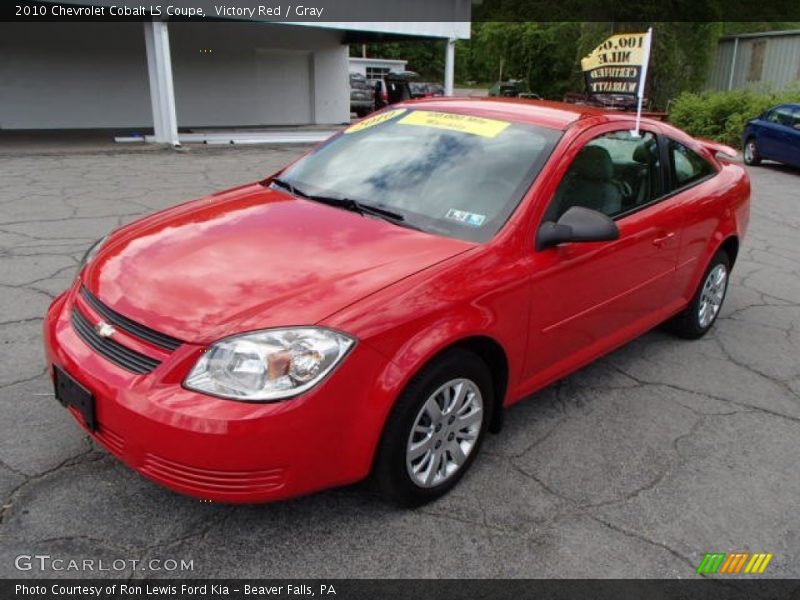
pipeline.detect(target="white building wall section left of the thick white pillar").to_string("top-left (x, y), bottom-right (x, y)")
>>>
top-left (0, 23), bottom-right (153, 129)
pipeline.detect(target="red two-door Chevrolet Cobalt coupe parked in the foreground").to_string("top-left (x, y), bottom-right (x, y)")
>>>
top-left (45, 99), bottom-right (750, 504)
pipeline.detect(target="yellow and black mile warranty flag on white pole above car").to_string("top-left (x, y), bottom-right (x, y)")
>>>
top-left (581, 31), bottom-right (652, 96)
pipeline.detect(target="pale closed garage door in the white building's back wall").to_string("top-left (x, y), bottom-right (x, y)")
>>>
top-left (253, 48), bottom-right (314, 125)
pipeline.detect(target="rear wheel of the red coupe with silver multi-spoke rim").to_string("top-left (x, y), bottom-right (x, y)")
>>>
top-left (668, 250), bottom-right (731, 340)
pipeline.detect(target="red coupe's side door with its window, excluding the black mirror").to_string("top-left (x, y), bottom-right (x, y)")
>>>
top-left (523, 123), bottom-right (682, 389)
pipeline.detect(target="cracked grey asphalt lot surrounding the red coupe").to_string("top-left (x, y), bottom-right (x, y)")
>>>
top-left (0, 139), bottom-right (800, 578)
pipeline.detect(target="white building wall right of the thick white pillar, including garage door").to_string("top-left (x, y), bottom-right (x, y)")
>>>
top-left (169, 22), bottom-right (350, 126)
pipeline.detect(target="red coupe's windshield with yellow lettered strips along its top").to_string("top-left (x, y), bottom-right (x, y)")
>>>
top-left (280, 108), bottom-right (560, 242)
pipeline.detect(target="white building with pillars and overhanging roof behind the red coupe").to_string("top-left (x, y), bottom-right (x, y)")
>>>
top-left (0, 17), bottom-right (469, 143)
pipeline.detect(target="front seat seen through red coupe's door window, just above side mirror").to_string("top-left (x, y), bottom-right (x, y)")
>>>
top-left (556, 146), bottom-right (622, 219)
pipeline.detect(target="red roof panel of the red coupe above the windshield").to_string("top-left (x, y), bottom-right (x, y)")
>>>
top-left (395, 97), bottom-right (649, 130)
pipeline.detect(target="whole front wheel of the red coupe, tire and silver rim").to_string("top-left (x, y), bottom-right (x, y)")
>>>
top-left (373, 349), bottom-right (494, 506)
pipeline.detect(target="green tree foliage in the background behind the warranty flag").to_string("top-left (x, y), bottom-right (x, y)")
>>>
top-left (351, 21), bottom-right (798, 110)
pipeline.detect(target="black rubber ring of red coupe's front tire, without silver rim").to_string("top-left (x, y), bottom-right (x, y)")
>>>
top-left (372, 348), bottom-right (494, 507)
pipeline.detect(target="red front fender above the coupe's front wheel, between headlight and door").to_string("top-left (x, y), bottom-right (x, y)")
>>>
top-left (325, 261), bottom-right (530, 468)
